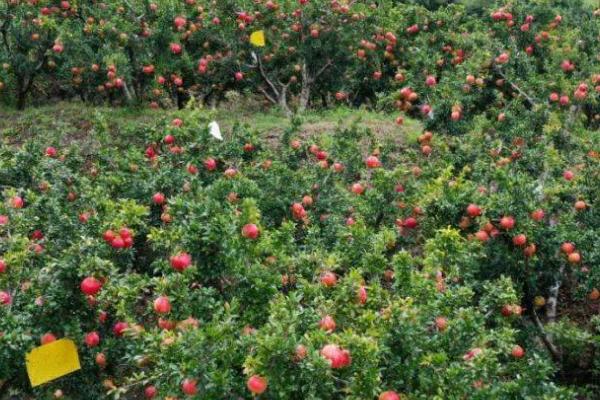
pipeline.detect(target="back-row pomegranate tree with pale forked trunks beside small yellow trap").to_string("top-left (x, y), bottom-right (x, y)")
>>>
top-left (239, 0), bottom-right (373, 113)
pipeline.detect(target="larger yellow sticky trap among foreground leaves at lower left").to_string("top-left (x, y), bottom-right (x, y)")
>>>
top-left (25, 339), bottom-right (81, 387)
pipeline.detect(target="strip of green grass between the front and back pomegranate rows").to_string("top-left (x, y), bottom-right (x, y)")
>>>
top-left (0, 102), bottom-right (421, 145)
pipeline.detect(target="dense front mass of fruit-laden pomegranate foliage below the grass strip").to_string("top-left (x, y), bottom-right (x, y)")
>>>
top-left (0, 102), bottom-right (600, 399)
